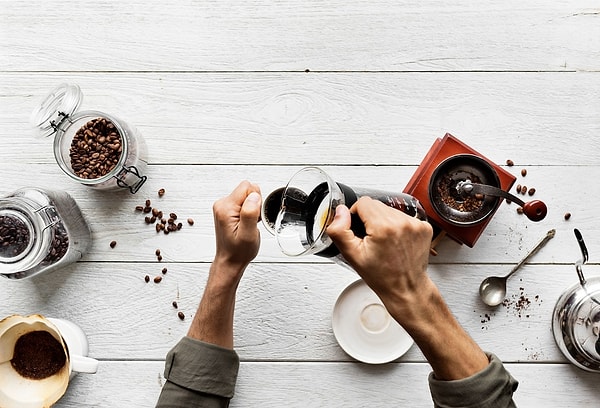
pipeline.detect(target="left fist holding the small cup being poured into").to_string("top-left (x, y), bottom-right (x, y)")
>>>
top-left (213, 181), bottom-right (261, 272)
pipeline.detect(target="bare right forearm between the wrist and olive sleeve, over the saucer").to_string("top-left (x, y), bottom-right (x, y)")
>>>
top-left (388, 280), bottom-right (489, 380)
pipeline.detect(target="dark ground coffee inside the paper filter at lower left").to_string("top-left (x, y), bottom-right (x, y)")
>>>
top-left (10, 330), bottom-right (67, 380)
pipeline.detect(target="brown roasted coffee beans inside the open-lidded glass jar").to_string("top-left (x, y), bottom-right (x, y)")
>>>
top-left (69, 118), bottom-right (123, 179)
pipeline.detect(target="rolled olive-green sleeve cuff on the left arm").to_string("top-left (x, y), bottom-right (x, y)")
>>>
top-left (156, 337), bottom-right (240, 408)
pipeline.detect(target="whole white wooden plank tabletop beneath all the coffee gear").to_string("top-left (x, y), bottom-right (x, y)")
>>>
top-left (0, 0), bottom-right (600, 407)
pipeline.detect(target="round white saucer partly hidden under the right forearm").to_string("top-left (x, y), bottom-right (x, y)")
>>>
top-left (332, 279), bottom-right (414, 364)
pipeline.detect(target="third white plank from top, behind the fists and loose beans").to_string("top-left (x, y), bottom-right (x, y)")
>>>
top-left (0, 162), bottom-right (600, 263)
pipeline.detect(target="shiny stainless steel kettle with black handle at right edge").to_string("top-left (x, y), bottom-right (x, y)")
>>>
top-left (552, 229), bottom-right (600, 373)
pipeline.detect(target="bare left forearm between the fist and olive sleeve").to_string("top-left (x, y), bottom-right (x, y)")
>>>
top-left (188, 259), bottom-right (245, 349)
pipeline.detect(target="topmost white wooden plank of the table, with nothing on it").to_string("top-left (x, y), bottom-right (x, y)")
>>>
top-left (0, 0), bottom-right (600, 72)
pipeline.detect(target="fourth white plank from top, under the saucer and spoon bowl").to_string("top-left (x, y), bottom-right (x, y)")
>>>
top-left (0, 262), bottom-right (600, 363)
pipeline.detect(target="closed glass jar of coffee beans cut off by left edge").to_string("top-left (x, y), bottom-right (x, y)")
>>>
top-left (0, 188), bottom-right (91, 279)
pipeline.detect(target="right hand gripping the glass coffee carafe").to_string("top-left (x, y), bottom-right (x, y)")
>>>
top-left (327, 197), bottom-right (433, 320)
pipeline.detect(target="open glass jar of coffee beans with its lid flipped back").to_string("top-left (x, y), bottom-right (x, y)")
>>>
top-left (31, 84), bottom-right (147, 194)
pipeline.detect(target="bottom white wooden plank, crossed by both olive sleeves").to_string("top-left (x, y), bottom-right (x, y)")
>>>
top-left (56, 361), bottom-right (597, 408)
